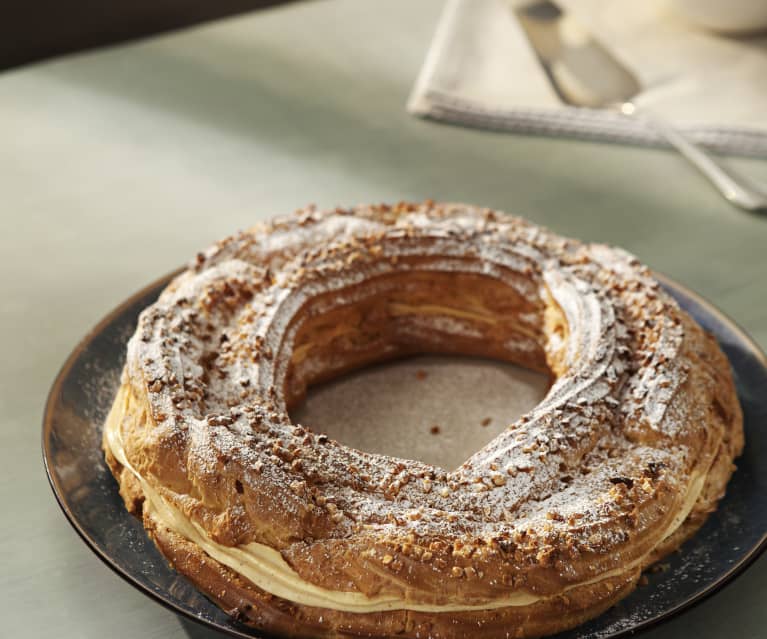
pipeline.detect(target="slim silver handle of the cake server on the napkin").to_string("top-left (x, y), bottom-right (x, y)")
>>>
top-left (624, 105), bottom-right (767, 211)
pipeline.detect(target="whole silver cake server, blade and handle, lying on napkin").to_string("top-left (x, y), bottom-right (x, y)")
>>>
top-left (510, 0), bottom-right (767, 211)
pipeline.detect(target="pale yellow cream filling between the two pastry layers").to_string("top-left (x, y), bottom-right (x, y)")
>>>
top-left (104, 386), bottom-right (706, 613)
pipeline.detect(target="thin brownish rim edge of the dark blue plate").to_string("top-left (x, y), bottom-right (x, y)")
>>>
top-left (41, 267), bottom-right (767, 639)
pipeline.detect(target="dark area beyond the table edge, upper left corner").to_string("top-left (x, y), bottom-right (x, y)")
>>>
top-left (0, 0), bottom-right (288, 69)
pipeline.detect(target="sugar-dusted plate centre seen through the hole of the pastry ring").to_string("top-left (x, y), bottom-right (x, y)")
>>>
top-left (290, 355), bottom-right (549, 469)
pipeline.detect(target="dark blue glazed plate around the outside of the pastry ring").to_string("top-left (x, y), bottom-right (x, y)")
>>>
top-left (43, 278), bottom-right (767, 639)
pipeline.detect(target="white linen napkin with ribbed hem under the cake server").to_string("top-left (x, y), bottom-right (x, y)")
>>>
top-left (408, 0), bottom-right (767, 157)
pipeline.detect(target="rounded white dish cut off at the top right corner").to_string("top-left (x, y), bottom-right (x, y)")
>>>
top-left (668, 0), bottom-right (767, 35)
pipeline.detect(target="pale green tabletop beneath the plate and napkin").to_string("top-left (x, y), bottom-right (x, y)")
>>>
top-left (0, 0), bottom-right (767, 639)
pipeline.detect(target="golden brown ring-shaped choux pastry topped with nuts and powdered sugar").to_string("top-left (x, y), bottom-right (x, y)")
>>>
top-left (105, 203), bottom-right (743, 637)
